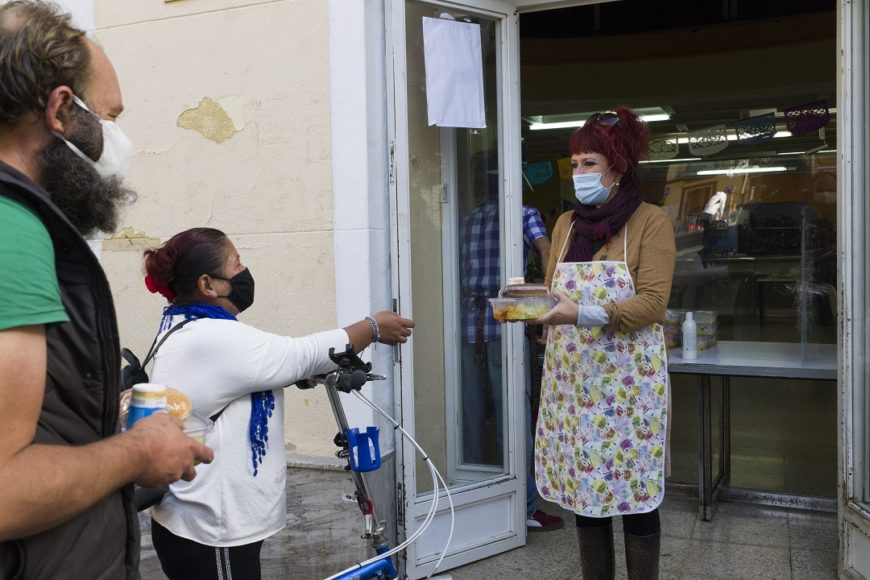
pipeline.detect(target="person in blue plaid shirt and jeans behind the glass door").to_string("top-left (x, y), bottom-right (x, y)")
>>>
top-left (459, 152), bottom-right (563, 531)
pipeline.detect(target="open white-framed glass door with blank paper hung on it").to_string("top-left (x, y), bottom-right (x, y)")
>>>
top-left (388, 0), bottom-right (528, 578)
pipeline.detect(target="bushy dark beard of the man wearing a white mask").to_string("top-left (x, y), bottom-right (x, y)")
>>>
top-left (39, 139), bottom-right (136, 236)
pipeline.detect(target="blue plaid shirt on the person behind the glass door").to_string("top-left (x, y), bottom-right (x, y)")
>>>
top-left (459, 200), bottom-right (547, 342)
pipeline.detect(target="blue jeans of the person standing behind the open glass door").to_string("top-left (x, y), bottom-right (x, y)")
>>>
top-left (460, 339), bottom-right (538, 516)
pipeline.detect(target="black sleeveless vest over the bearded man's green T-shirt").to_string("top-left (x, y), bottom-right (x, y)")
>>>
top-left (0, 162), bottom-right (139, 580)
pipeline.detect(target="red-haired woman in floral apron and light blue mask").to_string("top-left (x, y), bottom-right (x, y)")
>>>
top-left (535, 108), bottom-right (675, 580)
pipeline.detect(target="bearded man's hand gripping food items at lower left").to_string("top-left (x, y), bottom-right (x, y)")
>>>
top-left (122, 413), bottom-right (214, 488)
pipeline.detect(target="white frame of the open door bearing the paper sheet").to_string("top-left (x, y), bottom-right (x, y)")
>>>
top-left (385, 0), bottom-right (526, 578)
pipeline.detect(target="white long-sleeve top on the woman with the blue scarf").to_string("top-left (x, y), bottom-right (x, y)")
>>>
top-left (151, 316), bottom-right (349, 547)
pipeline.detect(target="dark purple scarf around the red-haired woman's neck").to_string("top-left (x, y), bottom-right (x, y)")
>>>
top-left (565, 178), bottom-right (643, 262)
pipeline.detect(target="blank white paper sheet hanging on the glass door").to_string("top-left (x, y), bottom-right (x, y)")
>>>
top-left (423, 18), bottom-right (486, 129)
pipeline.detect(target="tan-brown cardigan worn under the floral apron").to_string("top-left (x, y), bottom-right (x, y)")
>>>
top-left (545, 202), bottom-right (676, 332)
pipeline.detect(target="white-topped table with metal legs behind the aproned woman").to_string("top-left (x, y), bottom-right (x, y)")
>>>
top-left (668, 341), bottom-right (837, 521)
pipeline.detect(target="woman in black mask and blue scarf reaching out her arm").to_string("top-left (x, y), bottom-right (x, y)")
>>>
top-left (145, 228), bottom-right (414, 580)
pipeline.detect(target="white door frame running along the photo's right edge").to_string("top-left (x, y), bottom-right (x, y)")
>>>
top-left (837, 0), bottom-right (870, 578)
